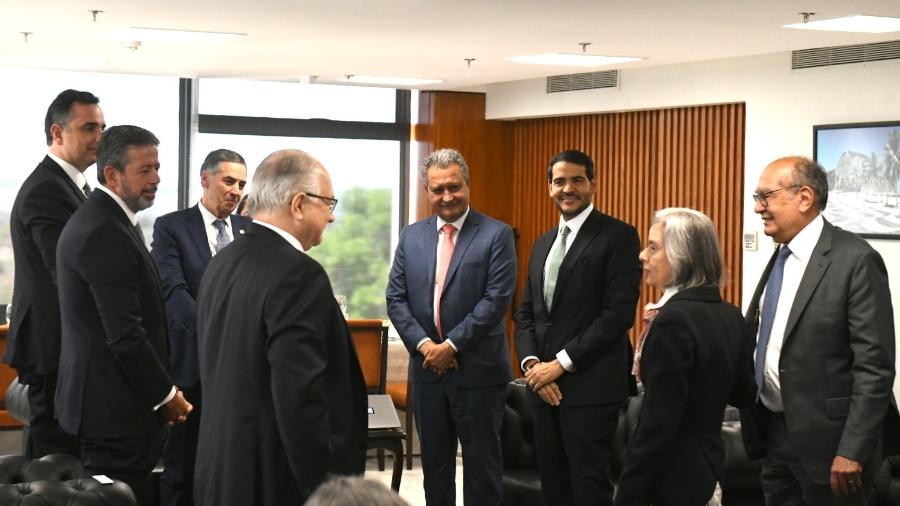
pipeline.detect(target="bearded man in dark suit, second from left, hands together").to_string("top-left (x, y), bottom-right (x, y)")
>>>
top-left (56, 125), bottom-right (191, 504)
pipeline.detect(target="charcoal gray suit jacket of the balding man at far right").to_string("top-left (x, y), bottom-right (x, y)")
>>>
top-left (741, 221), bottom-right (900, 484)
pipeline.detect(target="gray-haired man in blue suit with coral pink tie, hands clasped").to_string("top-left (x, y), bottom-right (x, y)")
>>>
top-left (387, 149), bottom-right (516, 506)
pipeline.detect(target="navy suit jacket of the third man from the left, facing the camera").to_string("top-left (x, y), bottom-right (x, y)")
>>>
top-left (150, 204), bottom-right (250, 388)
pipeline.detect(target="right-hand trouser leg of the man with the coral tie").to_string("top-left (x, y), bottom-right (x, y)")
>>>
top-left (447, 384), bottom-right (506, 506)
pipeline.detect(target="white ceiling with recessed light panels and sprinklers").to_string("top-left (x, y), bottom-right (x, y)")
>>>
top-left (0, 0), bottom-right (900, 89)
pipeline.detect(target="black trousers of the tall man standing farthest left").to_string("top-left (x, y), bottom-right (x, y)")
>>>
top-left (19, 373), bottom-right (81, 458)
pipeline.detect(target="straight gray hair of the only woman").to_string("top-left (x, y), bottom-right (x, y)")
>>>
top-left (651, 207), bottom-right (725, 289)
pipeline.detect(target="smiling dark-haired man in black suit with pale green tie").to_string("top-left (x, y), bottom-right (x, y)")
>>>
top-left (515, 150), bottom-right (641, 505)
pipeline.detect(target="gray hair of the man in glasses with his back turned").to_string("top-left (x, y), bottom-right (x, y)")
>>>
top-left (247, 149), bottom-right (322, 216)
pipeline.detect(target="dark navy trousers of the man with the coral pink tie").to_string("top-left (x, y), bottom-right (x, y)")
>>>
top-left (413, 380), bottom-right (506, 506)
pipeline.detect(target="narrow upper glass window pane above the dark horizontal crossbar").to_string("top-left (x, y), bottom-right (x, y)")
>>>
top-left (198, 79), bottom-right (397, 123)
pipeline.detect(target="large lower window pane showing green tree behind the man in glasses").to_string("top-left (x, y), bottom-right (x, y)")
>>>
top-left (190, 134), bottom-right (400, 319)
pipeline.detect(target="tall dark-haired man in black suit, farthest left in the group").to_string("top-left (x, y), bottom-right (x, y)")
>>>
top-left (4, 90), bottom-right (106, 457)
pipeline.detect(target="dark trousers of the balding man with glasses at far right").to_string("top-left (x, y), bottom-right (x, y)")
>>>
top-left (760, 412), bottom-right (881, 506)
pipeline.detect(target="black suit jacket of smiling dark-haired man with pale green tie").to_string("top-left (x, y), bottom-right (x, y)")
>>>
top-left (515, 210), bottom-right (642, 406)
